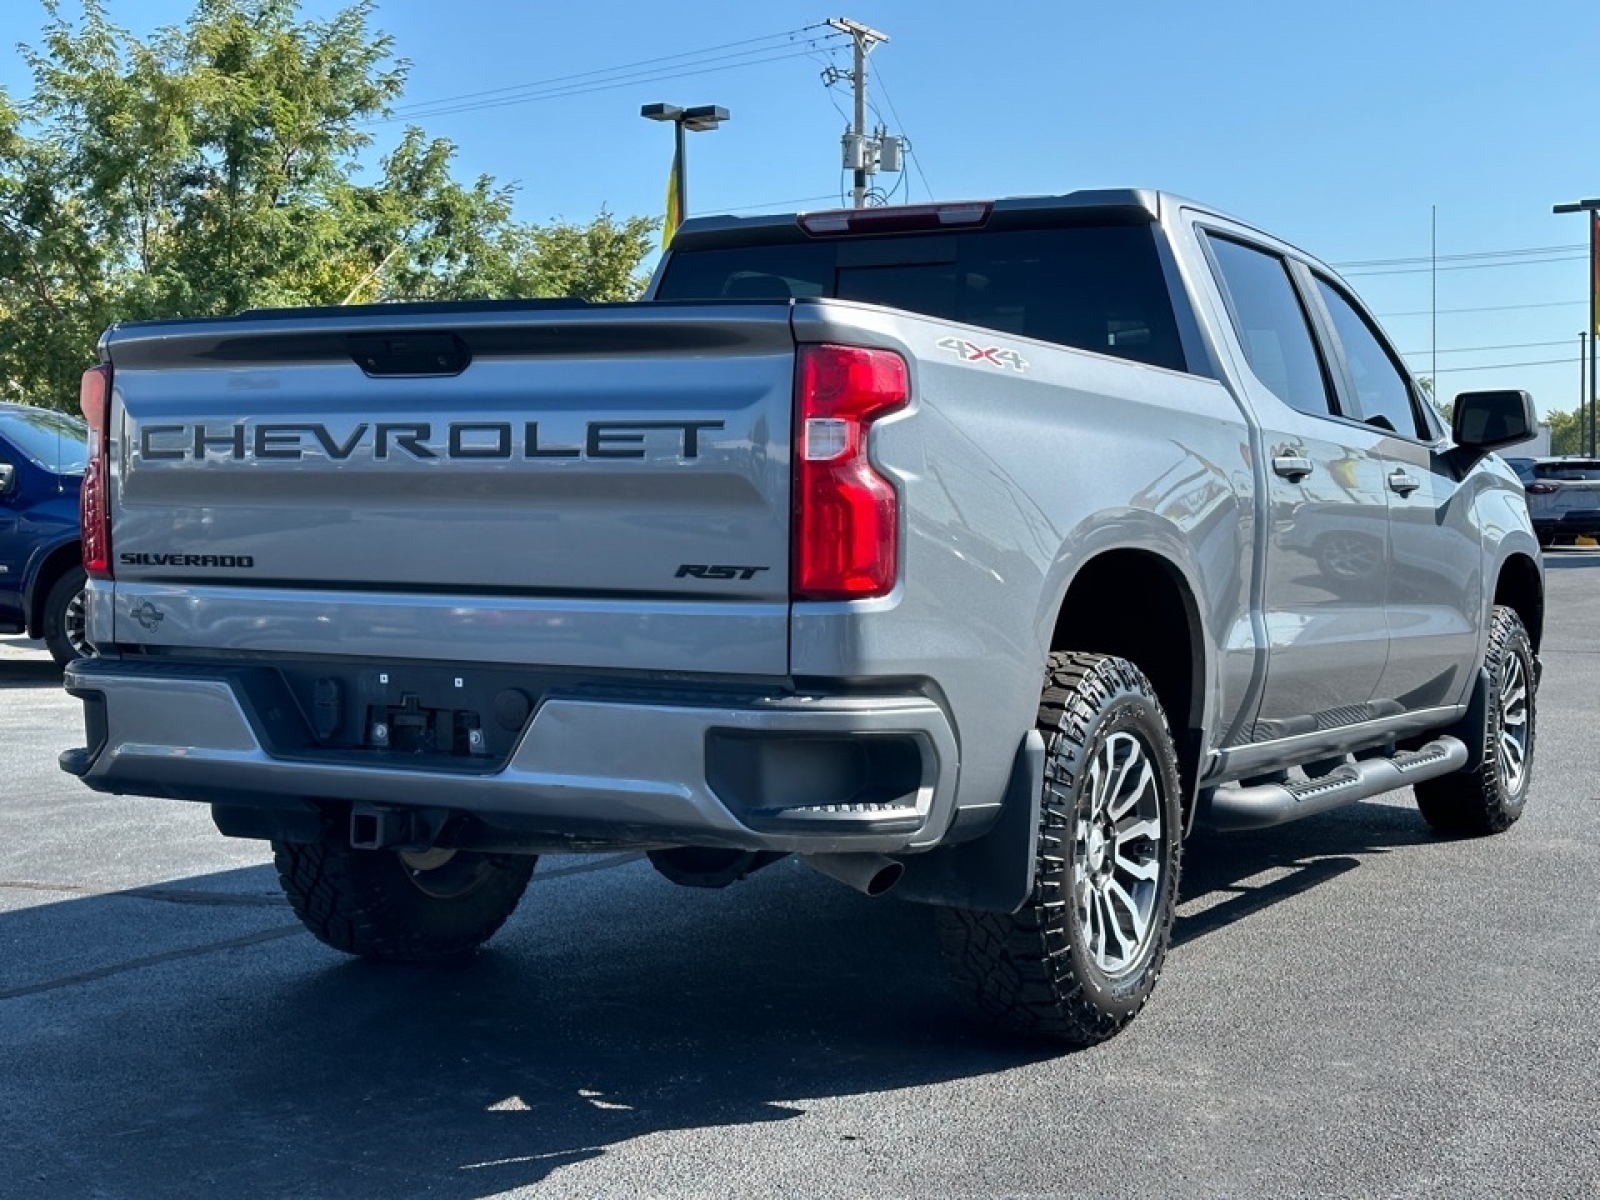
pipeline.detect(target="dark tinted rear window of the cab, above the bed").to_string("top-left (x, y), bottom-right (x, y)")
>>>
top-left (654, 224), bottom-right (1189, 371)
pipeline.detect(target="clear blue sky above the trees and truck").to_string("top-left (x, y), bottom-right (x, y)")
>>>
top-left (0, 0), bottom-right (1600, 422)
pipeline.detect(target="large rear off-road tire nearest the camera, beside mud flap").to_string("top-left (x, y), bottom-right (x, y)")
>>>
top-left (938, 654), bottom-right (1182, 1046)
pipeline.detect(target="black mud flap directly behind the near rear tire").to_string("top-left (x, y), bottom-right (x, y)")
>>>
top-left (893, 730), bottom-right (1045, 912)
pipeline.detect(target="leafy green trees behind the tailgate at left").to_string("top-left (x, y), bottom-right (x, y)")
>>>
top-left (0, 0), bottom-right (658, 408)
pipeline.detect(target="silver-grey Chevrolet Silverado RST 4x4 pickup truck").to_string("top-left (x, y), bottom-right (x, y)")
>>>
top-left (62, 190), bottom-right (1544, 1043)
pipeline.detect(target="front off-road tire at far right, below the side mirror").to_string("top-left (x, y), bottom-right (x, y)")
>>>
top-left (1413, 605), bottom-right (1539, 837)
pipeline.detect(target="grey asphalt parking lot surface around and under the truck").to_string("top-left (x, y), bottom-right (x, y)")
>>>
top-left (0, 550), bottom-right (1600, 1198)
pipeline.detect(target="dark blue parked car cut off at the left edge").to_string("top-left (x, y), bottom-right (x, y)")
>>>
top-left (0, 403), bottom-right (93, 664)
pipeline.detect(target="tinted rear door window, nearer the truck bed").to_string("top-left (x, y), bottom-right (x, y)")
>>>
top-left (1210, 237), bottom-right (1333, 416)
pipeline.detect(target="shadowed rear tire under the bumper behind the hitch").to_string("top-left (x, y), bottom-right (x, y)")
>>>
top-left (272, 840), bottom-right (538, 963)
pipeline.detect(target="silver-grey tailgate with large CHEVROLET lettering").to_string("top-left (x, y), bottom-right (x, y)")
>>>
top-left (107, 306), bottom-right (794, 670)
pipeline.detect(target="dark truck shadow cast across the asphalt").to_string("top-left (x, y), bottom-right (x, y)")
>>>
top-left (0, 793), bottom-right (1429, 1197)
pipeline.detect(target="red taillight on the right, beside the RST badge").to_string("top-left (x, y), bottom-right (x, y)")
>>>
top-left (790, 346), bottom-right (909, 600)
